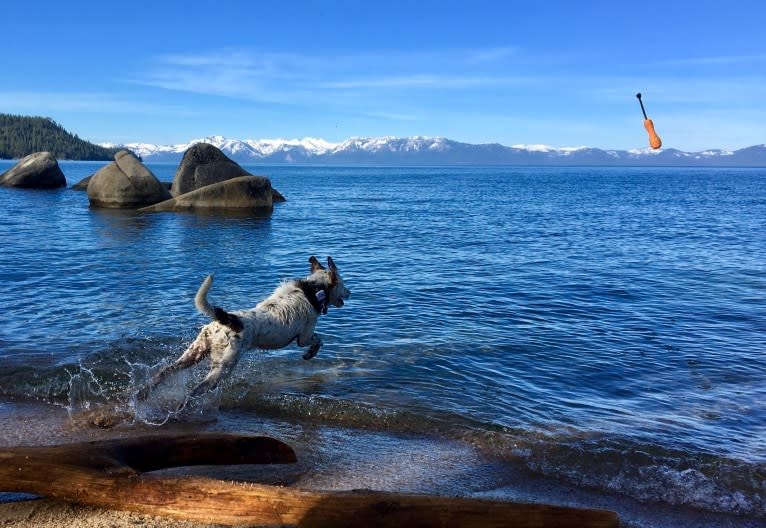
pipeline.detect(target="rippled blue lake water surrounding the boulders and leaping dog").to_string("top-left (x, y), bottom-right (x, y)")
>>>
top-left (0, 162), bottom-right (766, 523)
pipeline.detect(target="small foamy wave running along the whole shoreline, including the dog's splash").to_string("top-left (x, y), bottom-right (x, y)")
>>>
top-left (0, 344), bottom-right (766, 519)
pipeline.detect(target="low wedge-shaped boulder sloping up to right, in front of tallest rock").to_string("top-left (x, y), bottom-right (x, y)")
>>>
top-left (140, 175), bottom-right (274, 213)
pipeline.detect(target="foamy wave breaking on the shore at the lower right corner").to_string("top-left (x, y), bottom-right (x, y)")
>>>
top-left (468, 430), bottom-right (766, 518)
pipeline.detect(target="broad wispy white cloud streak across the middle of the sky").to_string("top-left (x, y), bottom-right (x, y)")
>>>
top-left (133, 48), bottom-right (534, 104)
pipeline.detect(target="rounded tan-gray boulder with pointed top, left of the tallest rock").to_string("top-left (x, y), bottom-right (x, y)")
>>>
top-left (88, 150), bottom-right (170, 208)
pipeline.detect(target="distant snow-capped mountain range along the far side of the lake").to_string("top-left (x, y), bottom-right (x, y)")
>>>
top-left (102, 136), bottom-right (766, 167)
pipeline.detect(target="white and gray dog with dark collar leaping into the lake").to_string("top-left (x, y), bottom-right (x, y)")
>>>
top-left (137, 256), bottom-right (351, 408)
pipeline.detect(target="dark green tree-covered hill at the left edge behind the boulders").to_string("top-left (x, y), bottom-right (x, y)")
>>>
top-left (0, 114), bottom-right (119, 160)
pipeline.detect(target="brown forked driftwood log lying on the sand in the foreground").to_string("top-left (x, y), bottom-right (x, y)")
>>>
top-left (0, 433), bottom-right (618, 527)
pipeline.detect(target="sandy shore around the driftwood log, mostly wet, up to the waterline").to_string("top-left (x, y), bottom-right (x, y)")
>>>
top-left (0, 403), bottom-right (766, 528)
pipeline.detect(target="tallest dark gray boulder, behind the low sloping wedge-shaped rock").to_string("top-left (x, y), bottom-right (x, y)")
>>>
top-left (170, 143), bottom-right (252, 196)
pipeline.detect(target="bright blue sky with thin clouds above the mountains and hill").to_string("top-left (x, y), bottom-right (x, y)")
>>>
top-left (0, 0), bottom-right (766, 151)
